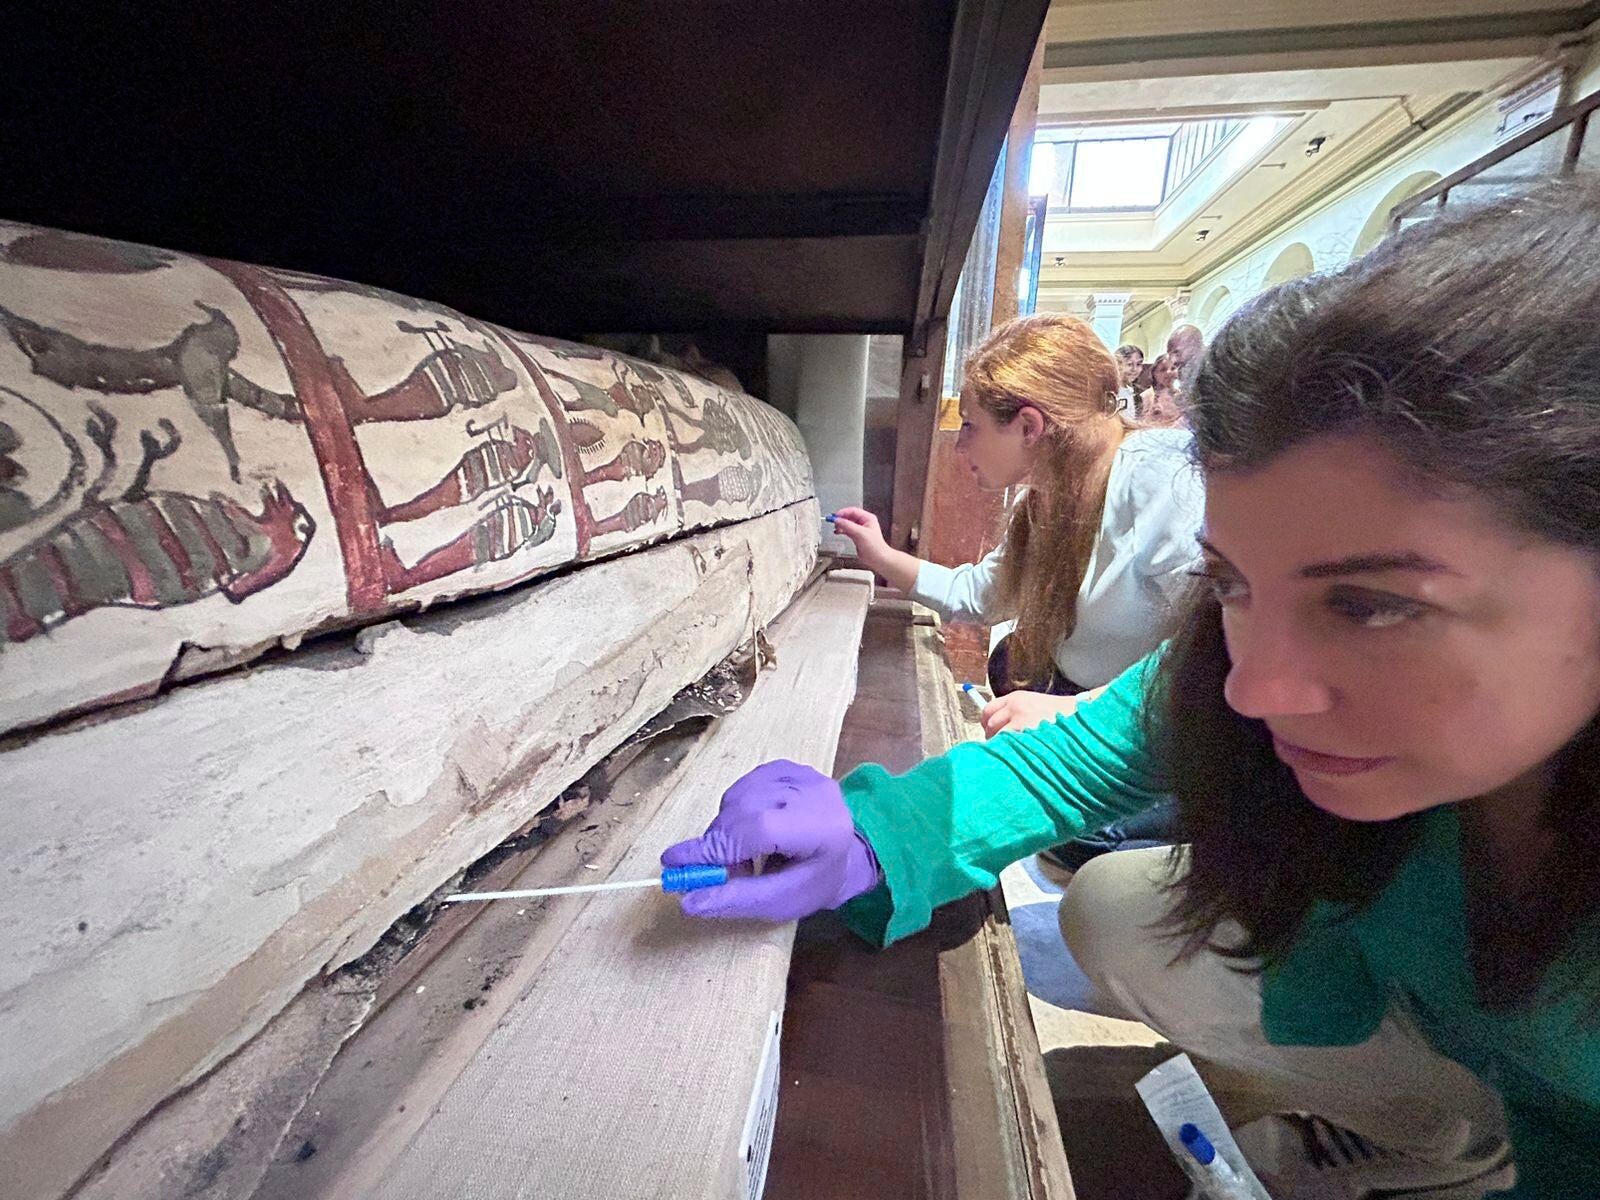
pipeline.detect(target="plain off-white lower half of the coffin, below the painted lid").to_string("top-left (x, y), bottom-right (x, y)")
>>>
top-left (0, 501), bottom-right (818, 1200)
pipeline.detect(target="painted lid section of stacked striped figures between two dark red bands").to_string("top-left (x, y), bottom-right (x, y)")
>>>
top-left (211, 264), bottom-right (573, 608)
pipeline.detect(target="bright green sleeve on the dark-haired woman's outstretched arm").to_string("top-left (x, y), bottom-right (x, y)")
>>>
top-left (840, 654), bottom-right (1168, 946)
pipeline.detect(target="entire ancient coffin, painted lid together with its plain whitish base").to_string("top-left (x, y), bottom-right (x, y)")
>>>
top-left (0, 226), bottom-right (818, 1200)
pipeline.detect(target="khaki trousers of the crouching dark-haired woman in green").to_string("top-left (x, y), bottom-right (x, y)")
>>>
top-left (1061, 848), bottom-right (1506, 1162)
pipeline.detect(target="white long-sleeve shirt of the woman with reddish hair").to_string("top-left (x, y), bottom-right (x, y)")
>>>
top-left (912, 429), bottom-right (1205, 688)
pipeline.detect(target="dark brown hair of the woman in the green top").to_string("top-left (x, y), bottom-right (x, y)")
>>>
top-left (1150, 179), bottom-right (1600, 1005)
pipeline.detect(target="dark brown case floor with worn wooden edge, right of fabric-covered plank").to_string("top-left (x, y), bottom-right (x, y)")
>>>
top-left (766, 611), bottom-right (1074, 1200)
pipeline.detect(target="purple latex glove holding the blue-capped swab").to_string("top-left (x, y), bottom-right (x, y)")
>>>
top-left (661, 758), bottom-right (878, 922)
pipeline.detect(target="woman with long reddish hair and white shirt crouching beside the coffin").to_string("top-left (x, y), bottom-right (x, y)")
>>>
top-left (832, 312), bottom-right (1203, 736)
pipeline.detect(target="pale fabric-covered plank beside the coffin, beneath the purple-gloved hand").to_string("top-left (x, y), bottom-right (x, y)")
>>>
top-left (371, 571), bottom-right (870, 1200)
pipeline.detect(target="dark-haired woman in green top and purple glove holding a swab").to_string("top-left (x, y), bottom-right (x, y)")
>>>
top-left (664, 179), bottom-right (1600, 1200)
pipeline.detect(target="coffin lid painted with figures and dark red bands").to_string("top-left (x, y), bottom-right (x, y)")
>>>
top-left (0, 224), bottom-right (813, 731)
